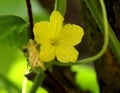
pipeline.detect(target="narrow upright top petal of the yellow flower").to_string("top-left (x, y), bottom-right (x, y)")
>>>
top-left (50, 11), bottom-right (64, 38)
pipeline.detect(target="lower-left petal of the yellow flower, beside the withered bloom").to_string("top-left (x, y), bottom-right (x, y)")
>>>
top-left (39, 44), bottom-right (55, 62)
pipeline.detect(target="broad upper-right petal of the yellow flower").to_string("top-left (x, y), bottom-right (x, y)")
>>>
top-left (59, 24), bottom-right (84, 46)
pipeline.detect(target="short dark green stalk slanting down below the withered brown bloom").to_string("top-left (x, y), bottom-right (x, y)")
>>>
top-left (29, 72), bottom-right (44, 93)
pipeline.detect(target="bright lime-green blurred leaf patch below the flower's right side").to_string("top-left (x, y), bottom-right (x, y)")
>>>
top-left (71, 65), bottom-right (100, 93)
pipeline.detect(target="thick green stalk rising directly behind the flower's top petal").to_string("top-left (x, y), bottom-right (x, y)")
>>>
top-left (54, 0), bottom-right (67, 16)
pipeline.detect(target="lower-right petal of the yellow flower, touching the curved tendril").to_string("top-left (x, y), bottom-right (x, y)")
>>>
top-left (56, 45), bottom-right (79, 63)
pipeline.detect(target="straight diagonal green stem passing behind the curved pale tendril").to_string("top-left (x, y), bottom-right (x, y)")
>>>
top-left (84, 0), bottom-right (120, 62)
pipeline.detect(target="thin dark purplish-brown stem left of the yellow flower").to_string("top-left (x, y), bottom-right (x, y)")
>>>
top-left (26, 0), bottom-right (34, 39)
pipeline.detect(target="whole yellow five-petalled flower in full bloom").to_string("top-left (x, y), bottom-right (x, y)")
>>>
top-left (33, 11), bottom-right (84, 63)
